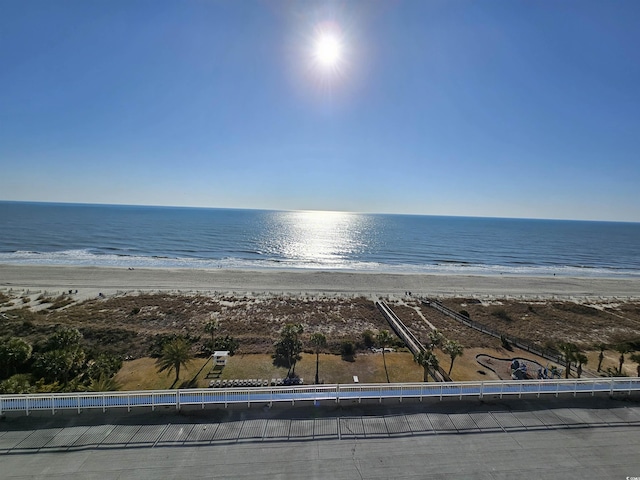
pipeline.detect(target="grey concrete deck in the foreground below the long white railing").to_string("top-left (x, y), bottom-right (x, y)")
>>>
top-left (0, 398), bottom-right (640, 480)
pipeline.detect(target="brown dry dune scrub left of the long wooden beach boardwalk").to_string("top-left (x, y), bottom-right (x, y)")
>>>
top-left (0, 293), bottom-right (388, 358)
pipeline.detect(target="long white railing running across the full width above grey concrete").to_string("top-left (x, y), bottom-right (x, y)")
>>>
top-left (0, 377), bottom-right (640, 415)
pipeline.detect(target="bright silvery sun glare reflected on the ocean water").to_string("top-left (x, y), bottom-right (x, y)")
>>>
top-left (265, 211), bottom-right (366, 268)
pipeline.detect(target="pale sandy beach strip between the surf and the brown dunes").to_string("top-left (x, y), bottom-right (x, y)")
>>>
top-left (0, 264), bottom-right (640, 300)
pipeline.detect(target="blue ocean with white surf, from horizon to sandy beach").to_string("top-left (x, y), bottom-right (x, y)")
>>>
top-left (0, 202), bottom-right (640, 277)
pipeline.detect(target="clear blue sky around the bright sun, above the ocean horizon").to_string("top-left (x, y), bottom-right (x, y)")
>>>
top-left (0, 0), bottom-right (640, 221)
